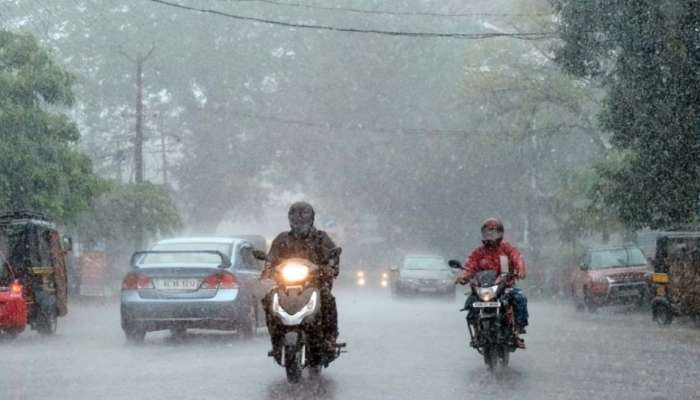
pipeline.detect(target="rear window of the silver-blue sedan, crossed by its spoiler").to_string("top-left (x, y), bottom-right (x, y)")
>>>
top-left (139, 243), bottom-right (231, 267)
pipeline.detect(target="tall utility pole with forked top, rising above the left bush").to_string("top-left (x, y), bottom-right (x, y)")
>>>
top-left (120, 45), bottom-right (156, 250)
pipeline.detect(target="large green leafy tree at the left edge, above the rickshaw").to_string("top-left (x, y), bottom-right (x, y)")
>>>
top-left (0, 31), bottom-right (103, 222)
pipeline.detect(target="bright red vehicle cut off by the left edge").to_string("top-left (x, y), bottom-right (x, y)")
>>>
top-left (0, 254), bottom-right (27, 338)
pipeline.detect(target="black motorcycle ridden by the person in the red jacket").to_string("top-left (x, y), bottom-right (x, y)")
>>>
top-left (449, 260), bottom-right (518, 371)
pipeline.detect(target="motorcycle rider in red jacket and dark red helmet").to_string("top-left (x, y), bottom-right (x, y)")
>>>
top-left (456, 218), bottom-right (529, 348)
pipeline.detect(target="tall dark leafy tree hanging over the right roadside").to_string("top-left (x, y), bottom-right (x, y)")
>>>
top-left (553, 0), bottom-right (700, 229)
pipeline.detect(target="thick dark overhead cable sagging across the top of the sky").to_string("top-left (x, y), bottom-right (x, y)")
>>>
top-left (149, 0), bottom-right (556, 40)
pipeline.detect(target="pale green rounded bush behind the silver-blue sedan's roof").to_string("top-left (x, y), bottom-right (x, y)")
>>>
top-left (79, 182), bottom-right (182, 241)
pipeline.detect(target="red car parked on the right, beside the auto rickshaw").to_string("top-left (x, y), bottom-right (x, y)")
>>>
top-left (571, 245), bottom-right (651, 311)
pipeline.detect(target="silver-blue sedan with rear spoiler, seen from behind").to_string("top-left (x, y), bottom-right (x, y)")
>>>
top-left (121, 237), bottom-right (264, 342)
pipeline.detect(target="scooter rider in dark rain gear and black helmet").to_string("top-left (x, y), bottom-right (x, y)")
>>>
top-left (261, 202), bottom-right (340, 362)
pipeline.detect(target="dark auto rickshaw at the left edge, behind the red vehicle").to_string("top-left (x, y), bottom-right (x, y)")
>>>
top-left (0, 211), bottom-right (68, 335)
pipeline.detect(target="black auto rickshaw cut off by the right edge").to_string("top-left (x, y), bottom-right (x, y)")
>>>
top-left (651, 232), bottom-right (700, 325)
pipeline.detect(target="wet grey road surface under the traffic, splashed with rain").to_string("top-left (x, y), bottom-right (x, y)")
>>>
top-left (0, 291), bottom-right (700, 400)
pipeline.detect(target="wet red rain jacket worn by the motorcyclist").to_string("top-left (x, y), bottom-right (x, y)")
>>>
top-left (464, 242), bottom-right (527, 280)
